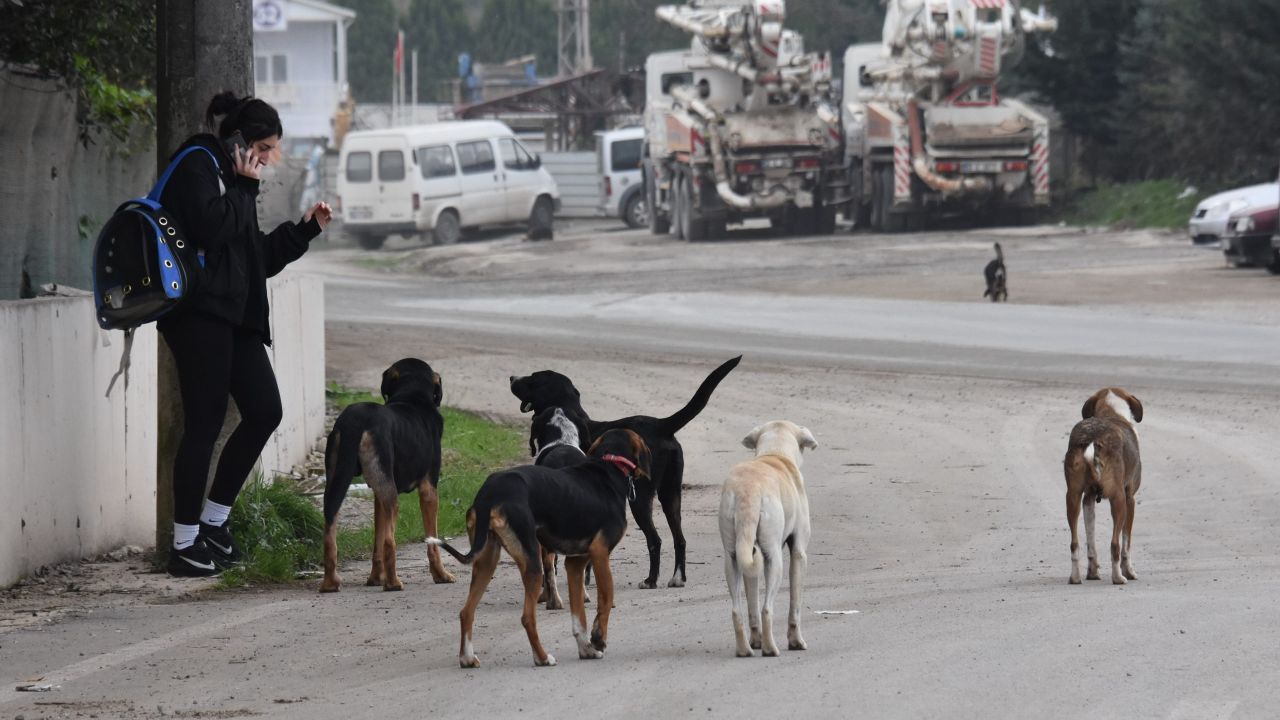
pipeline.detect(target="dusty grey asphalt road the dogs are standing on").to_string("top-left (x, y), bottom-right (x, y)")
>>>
top-left (0, 224), bottom-right (1280, 719)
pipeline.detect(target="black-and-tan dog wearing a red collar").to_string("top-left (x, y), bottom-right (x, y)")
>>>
top-left (428, 430), bottom-right (649, 667)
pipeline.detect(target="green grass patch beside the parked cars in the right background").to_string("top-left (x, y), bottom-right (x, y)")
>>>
top-left (1064, 179), bottom-right (1207, 229)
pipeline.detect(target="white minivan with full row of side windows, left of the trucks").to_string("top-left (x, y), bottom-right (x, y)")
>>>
top-left (338, 120), bottom-right (559, 250)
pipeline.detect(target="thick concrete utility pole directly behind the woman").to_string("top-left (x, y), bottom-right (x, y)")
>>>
top-left (156, 0), bottom-right (253, 562)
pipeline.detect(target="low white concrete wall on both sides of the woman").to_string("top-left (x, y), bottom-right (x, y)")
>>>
top-left (0, 270), bottom-right (325, 587)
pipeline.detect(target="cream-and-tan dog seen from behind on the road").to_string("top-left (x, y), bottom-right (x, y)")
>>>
top-left (719, 420), bottom-right (818, 657)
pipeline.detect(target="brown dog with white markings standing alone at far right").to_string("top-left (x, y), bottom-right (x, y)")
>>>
top-left (1062, 387), bottom-right (1142, 585)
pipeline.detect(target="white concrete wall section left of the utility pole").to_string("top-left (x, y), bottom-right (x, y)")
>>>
top-left (0, 296), bottom-right (156, 587)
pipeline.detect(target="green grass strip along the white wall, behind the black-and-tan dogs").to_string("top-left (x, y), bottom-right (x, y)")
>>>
top-left (221, 383), bottom-right (527, 587)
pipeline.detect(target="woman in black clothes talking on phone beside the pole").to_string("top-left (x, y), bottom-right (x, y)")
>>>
top-left (157, 92), bottom-right (332, 577)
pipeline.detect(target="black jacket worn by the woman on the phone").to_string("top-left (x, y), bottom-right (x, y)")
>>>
top-left (159, 135), bottom-right (320, 345)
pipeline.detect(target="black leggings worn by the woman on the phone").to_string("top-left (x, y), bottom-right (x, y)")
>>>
top-left (164, 313), bottom-right (283, 525)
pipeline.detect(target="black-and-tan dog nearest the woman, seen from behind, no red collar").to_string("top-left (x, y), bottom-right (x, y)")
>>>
top-left (320, 357), bottom-right (453, 592)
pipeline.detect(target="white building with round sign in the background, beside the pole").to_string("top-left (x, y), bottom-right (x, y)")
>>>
top-left (253, 0), bottom-right (356, 143)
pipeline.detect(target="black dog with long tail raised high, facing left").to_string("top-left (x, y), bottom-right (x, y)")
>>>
top-left (511, 355), bottom-right (742, 588)
